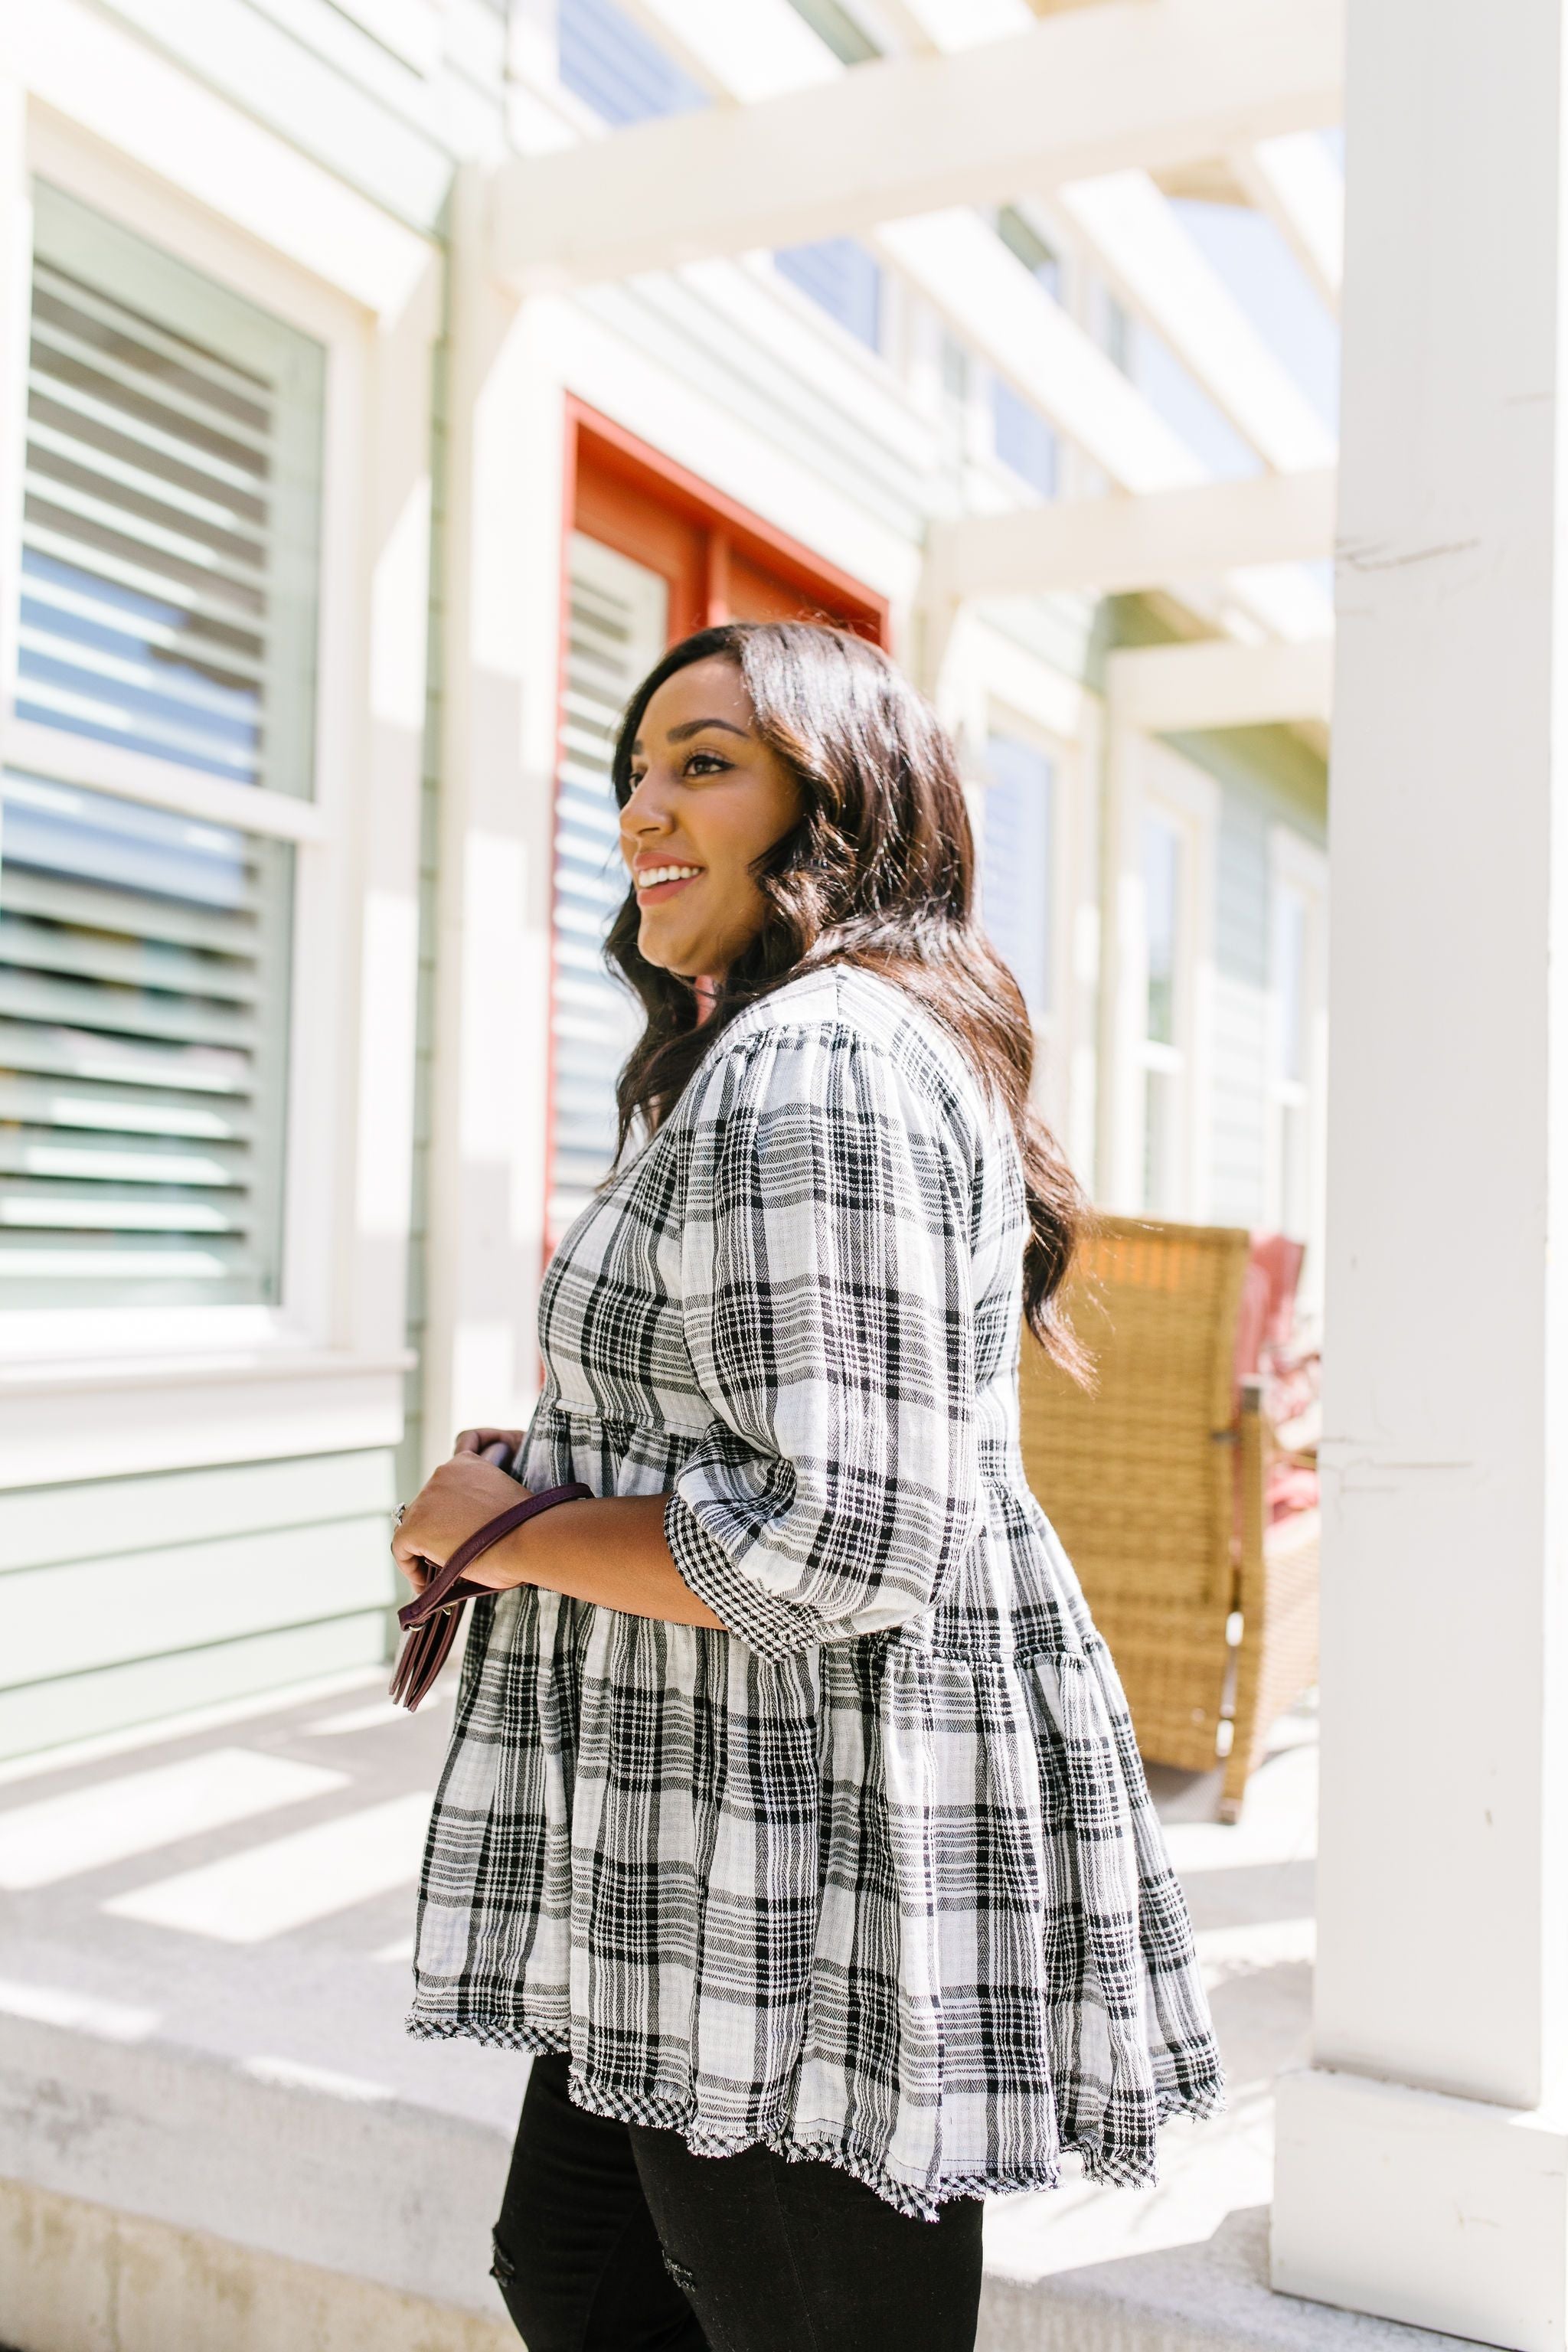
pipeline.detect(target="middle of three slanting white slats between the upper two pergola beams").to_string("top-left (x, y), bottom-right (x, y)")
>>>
top-left (1058, 172), bottom-right (1335, 472)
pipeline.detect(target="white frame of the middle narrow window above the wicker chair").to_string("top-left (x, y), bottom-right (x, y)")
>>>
top-left (1107, 731), bottom-right (1220, 1226)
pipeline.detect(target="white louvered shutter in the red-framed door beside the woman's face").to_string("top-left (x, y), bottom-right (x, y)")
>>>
top-left (545, 531), bottom-right (670, 1249)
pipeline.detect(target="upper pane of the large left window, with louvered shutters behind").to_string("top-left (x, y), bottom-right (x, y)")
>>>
top-left (16, 186), bottom-right (322, 792)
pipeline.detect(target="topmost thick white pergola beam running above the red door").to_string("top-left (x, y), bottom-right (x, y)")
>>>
top-left (492, 0), bottom-right (1344, 292)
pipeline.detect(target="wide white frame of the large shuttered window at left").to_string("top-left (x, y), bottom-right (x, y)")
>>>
top-left (0, 91), bottom-right (439, 1484)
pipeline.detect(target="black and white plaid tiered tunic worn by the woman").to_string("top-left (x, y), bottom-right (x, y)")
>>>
top-left (409, 967), bottom-right (1223, 2216)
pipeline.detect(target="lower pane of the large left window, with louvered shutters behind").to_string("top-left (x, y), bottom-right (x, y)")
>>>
top-left (0, 776), bottom-right (292, 1308)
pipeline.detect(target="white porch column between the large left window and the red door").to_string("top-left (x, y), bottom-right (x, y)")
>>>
top-left (423, 167), bottom-right (564, 1468)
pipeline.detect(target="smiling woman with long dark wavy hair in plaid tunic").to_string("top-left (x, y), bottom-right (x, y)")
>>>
top-left (393, 623), bottom-right (1223, 2352)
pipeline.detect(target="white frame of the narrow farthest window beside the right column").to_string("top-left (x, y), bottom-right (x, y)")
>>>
top-left (1263, 825), bottom-right (1328, 1312)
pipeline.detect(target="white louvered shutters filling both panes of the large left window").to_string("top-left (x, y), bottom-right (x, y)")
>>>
top-left (0, 188), bottom-right (322, 1305)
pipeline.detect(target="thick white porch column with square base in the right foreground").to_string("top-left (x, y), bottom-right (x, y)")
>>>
top-left (1274, 0), bottom-right (1568, 2352)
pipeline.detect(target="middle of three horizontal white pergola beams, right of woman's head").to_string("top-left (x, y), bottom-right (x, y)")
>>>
top-left (926, 470), bottom-right (1335, 602)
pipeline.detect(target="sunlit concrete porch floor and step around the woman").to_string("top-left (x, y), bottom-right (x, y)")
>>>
top-left (0, 1677), bottom-right (1476, 2352)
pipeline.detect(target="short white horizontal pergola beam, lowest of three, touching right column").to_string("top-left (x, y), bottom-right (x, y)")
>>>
top-left (1105, 638), bottom-right (1333, 733)
